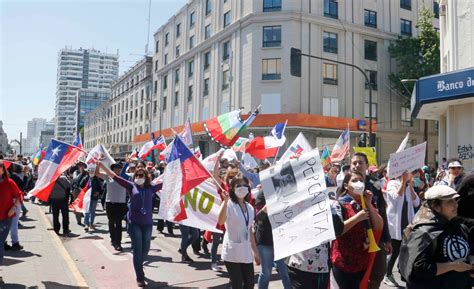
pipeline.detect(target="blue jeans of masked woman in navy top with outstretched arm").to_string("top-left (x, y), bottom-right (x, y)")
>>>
top-left (128, 223), bottom-right (153, 281)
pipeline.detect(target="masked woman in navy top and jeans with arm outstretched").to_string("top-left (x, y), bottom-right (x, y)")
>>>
top-left (98, 162), bottom-right (162, 287)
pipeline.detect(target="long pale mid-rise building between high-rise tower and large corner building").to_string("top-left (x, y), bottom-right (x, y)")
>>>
top-left (84, 57), bottom-right (153, 156)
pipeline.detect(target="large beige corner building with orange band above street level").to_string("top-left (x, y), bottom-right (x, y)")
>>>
top-left (131, 0), bottom-right (438, 163)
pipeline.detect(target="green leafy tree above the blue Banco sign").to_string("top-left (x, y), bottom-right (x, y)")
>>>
top-left (388, 7), bottom-right (440, 105)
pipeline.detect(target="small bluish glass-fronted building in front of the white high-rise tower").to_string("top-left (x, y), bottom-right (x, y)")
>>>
top-left (75, 88), bottom-right (111, 139)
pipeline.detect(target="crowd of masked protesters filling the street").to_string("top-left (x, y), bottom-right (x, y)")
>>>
top-left (0, 148), bottom-right (474, 289)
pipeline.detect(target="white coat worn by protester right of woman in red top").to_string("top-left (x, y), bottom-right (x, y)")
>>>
top-left (387, 179), bottom-right (420, 240)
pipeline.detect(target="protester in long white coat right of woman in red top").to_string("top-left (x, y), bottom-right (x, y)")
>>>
top-left (383, 172), bottom-right (420, 287)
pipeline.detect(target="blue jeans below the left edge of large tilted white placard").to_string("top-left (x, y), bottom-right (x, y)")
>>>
top-left (257, 245), bottom-right (291, 289)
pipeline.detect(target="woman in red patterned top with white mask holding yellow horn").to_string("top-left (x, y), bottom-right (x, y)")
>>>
top-left (331, 172), bottom-right (383, 289)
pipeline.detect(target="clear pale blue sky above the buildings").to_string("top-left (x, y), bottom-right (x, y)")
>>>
top-left (0, 0), bottom-right (188, 140)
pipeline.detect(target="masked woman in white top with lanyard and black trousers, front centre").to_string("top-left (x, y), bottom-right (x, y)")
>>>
top-left (218, 175), bottom-right (260, 289)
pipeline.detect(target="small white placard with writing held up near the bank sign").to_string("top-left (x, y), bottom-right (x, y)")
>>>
top-left (388, 142), bottom-right (426, 179)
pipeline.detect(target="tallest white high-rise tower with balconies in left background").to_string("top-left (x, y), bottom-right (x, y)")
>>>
top-left (55, 48), bottom-right (119, 143)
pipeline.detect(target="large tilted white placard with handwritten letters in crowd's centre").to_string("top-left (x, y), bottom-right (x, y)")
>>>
top-left (260, 149), bottom-right (335, 260)
